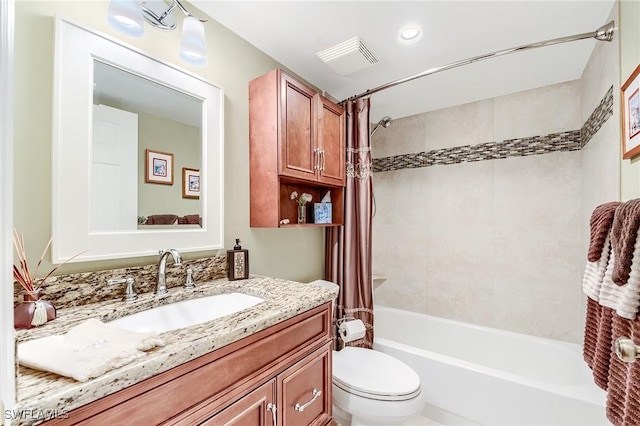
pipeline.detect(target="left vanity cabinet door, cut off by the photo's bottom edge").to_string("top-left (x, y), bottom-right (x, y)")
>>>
top-left (200, 379), bottom-right (276, 426)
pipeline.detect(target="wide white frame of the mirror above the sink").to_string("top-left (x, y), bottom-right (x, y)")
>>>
top-left (51, 17), bottom-right (224, 263)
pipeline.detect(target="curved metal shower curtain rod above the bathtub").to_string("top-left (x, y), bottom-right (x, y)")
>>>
top-left (340, 21), bottom-right (616, 104)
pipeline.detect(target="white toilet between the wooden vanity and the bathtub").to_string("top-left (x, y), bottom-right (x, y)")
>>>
top-left (311, 280), bottom-right (424, 426)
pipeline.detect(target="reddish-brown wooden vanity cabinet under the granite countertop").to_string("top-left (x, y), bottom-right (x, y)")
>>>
top-left (41, 303), bottom-right (332, 426)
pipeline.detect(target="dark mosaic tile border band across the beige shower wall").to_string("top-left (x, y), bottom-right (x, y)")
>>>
top-left (373, 86), bottom-right (613, 173)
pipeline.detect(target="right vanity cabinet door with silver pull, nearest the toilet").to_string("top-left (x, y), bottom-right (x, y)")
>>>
top-left (277, 343), bottom-right (331, 426)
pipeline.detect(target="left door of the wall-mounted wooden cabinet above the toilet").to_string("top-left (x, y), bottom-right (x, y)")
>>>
top-left (278, 73), bottom-right (318, 181)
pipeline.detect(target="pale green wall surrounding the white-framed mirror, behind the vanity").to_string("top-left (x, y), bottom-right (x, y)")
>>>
top-left (14, 0), bottom-right (324, 281)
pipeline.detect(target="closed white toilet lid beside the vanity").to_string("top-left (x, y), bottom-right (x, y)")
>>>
top-left (333, 346), bottom-right (420, 401)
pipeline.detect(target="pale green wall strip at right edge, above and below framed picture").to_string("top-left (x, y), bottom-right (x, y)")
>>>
top-left (618, 0), bottom-right (640, 201)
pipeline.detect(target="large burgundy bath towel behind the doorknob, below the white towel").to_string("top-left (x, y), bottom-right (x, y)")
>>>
top-left (607, 315), bottom-right (640, 426)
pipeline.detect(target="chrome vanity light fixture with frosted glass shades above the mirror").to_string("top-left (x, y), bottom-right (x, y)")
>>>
top-left (107, 0), bottom-right (207, 66)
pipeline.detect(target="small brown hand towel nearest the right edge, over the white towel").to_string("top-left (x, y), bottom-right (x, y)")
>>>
top-left (611, 199), bottom-right (640, 285)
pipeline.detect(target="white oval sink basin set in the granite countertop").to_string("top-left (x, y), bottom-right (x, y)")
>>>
top-left (109, 293), bottom-right (264, 333)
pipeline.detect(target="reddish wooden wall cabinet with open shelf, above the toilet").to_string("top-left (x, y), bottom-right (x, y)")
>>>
top-left (249, 70), bottom-right (345, 227)
